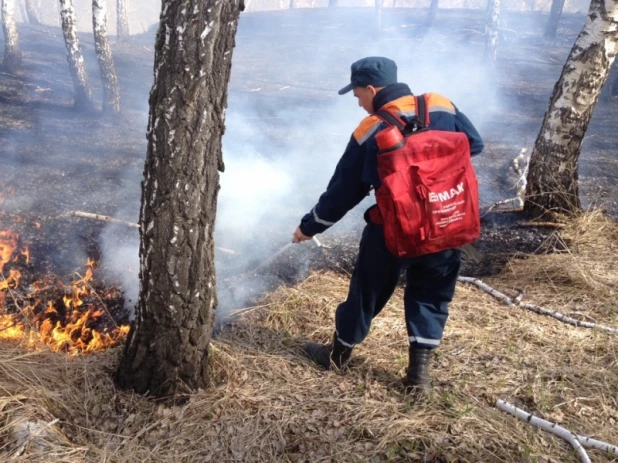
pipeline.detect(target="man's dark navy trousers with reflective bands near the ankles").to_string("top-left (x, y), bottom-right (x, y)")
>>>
top-left (335, 223), bottom-right (461, 349)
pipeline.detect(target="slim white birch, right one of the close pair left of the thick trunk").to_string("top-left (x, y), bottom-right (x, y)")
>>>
top-left (92, 0), bottom-right (120, 113)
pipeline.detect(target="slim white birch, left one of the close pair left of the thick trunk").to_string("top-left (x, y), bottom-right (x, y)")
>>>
top-left (59, 0), bottom-right (94, 110)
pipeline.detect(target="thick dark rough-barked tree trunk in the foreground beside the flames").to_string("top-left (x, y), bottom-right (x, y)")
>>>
top-left (116, 0), bottom-right (244, 397)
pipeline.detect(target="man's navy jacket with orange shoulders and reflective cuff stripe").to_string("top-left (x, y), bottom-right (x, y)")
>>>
top-left (300, 84), bottom-right (483, 236)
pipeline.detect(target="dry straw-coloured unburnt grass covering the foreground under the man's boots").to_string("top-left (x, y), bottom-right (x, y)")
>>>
top-left (0, 214), bottom-right (618, 462)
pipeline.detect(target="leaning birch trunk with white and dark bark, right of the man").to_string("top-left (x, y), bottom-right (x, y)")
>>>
top-left (524, 0), bottom-right (618, 217)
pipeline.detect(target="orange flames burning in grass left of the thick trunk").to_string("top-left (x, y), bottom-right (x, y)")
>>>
top-left (0, 230), bottom-right (129, 355)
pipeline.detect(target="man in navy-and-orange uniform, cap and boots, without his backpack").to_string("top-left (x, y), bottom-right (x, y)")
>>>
top-left (292, 57), bottom-right (483, 394)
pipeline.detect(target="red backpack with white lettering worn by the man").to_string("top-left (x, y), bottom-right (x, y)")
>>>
top-left (369, 95), bottom-right (481, 257)
